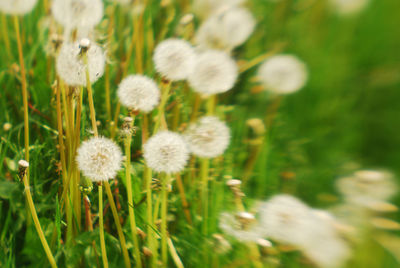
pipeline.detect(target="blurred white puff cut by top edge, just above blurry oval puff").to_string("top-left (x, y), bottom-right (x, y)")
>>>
top-left (192, 0), bottom-right (246, 18)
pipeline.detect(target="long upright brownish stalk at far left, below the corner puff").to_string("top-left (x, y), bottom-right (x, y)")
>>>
top-left (14, 16), bottom-right (29, 178)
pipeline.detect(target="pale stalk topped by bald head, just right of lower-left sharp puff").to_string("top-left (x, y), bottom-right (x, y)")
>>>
top-left (125, 117), bottom-right (142, 267)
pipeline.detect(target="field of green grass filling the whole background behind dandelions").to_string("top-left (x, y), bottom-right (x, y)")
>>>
top-left (0, 0), bottom-right (400, 268)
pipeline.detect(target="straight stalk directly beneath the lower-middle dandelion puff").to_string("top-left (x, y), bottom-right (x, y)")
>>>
top-left (161, 174), bottom-right (171, 266)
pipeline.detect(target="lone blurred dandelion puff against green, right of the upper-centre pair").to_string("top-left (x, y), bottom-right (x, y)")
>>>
top-left (258, 55), bottom-right (308, 94)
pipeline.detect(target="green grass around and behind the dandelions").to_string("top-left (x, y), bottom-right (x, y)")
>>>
top-left (0, 0), bottom-right (400, 267)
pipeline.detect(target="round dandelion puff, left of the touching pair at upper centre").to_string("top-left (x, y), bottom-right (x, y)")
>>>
top-left (153, 38), bottom-right (196, 81)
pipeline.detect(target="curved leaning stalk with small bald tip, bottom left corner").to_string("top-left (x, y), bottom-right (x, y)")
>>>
top-left (23, 174), bottom-right (57, 268)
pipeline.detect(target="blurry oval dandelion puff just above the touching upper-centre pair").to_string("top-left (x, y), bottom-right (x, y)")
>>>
top-left (196, 7), bottom-right (256, 50)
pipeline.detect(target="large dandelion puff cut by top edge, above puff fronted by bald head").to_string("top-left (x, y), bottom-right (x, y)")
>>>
top-left (51, 0), bottom-right (104, 29)
